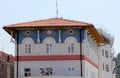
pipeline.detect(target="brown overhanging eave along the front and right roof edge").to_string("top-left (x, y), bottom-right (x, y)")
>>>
top-left (3, 24), bottom-right (104, 44)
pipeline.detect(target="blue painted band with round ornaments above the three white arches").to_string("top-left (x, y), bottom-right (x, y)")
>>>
top-left (15, 29), bottom-right (86, 44)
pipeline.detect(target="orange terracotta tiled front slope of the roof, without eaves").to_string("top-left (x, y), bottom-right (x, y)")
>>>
top-left (4, 18), bottom-right (91, 27)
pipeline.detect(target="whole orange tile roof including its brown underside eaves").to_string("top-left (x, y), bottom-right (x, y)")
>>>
top-left (3, 18), bottom-right (104, 43)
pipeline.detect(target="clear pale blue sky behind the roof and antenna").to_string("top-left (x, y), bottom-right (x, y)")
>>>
top-left (0, 0), bottom-right (120, 54)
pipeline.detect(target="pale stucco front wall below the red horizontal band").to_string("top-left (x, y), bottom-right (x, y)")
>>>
top-left (14, 60), bottom-right (80, 76)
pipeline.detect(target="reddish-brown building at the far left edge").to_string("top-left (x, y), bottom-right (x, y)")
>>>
top-left (0, 51), bottom-right (14, 78)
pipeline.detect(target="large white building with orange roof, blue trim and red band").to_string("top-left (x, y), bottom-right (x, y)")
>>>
top-left (3, 18), bottom-right (115, 78)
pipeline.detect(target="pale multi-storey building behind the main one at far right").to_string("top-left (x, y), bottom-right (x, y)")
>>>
top-left (98, 29), bottom-right (115, 78)
